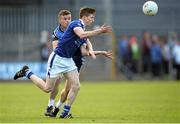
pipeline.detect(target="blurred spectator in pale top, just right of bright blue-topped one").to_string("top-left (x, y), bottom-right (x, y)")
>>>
top-left (161, 36), bottom-right (171, 76)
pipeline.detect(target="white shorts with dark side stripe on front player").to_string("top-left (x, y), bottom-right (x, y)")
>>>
top-left (46, 52), bottom-right (77, 78)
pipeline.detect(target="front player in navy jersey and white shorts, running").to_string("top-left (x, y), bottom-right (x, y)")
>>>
top-left (14, 7), bottom-right (112, 118)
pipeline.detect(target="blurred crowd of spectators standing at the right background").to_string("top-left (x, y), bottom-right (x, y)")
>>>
top-left (117, 32), bottom-right (180, 80)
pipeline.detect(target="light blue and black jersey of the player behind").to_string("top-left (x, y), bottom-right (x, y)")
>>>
top-left (52, 26), bottom-right (64, 41)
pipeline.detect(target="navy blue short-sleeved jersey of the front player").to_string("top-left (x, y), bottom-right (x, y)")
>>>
top-left (55, 20), bottom-right (87, 58)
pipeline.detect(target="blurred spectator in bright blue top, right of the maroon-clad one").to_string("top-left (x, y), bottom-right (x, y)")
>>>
top-left (151, 35), bottom-right (162, 76)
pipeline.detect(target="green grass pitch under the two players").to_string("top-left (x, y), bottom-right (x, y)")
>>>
top-left (0, 81), bottom-right (180, 123)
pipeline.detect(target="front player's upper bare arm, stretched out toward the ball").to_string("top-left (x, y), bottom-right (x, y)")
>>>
top-left (74, 24), bottom-right (112, 39)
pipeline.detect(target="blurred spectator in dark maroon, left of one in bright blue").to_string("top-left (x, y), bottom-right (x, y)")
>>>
top-left (142, 32), bottom-right (152, 72)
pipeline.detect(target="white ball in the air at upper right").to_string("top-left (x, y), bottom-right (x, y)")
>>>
top-left (142, 1), bottom-right (158, 16)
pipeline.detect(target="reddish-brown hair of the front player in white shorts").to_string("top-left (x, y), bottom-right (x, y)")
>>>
top-left (79, 7), bottom-right (96, 18)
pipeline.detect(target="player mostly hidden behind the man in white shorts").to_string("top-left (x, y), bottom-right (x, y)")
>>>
top-left (45, 10), bottom-right (112, 117)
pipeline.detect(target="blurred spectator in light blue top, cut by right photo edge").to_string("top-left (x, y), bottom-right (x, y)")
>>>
top-left (172, 41), bottom-right (180, 80)
